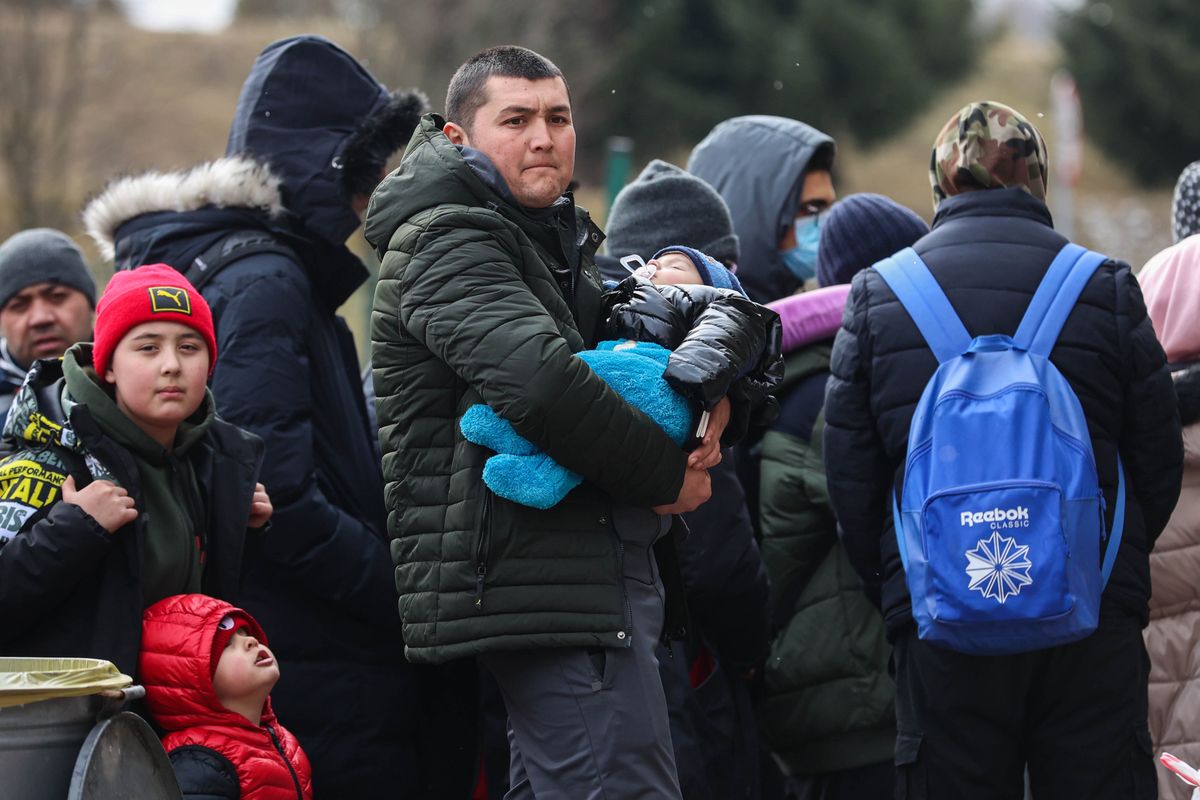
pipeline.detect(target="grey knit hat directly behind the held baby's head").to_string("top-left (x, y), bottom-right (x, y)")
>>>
top-left (605, 158), bottom-right (738, 263)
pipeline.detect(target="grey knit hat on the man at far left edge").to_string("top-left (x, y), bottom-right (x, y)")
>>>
top-left (0, 228), bottom-right (96, 308)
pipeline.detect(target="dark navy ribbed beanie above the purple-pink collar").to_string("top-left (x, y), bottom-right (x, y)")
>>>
top-left (817, 192), bottom-right (929, 287)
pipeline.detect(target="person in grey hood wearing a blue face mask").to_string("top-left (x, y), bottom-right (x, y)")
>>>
top-left (688, 115), bottom-right (838, 302)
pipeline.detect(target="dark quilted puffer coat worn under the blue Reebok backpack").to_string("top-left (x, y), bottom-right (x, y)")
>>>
top-left (824, 188), bottom-right (1183, 634)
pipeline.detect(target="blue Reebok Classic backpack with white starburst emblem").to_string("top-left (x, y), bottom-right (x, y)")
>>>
top-left (875, 243), bottom-right (1124, 655)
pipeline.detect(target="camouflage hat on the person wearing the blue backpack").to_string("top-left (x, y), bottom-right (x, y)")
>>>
top-left (929, 101), bottom-right (1049, 210)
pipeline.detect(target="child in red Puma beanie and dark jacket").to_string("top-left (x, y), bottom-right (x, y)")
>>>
top-left (0, 264), bottom-right (272, 674)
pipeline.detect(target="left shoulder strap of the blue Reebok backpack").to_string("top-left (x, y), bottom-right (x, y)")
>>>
top-left (875, 247), bottom-right (971, 363)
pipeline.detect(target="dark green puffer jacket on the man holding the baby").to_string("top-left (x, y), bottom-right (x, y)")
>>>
top-left (366, 115), bottom-right (686, 663)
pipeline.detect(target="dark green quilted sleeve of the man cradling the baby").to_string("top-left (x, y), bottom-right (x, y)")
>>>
top-left (400, 213), bottom-right (686, 506)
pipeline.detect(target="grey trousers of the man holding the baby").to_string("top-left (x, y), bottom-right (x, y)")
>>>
top-left (481, 507), bottom-right (680, 800)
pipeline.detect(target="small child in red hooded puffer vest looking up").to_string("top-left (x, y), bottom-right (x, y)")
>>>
top-left (138, 595), bottom-right (312, 800)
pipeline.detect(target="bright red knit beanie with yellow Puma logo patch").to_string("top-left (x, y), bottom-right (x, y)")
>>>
top-left (91, 264), bottom-right (217, 380)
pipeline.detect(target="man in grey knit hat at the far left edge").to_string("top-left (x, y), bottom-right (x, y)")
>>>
top-left (0, 228), bottom-right (96, 414)
